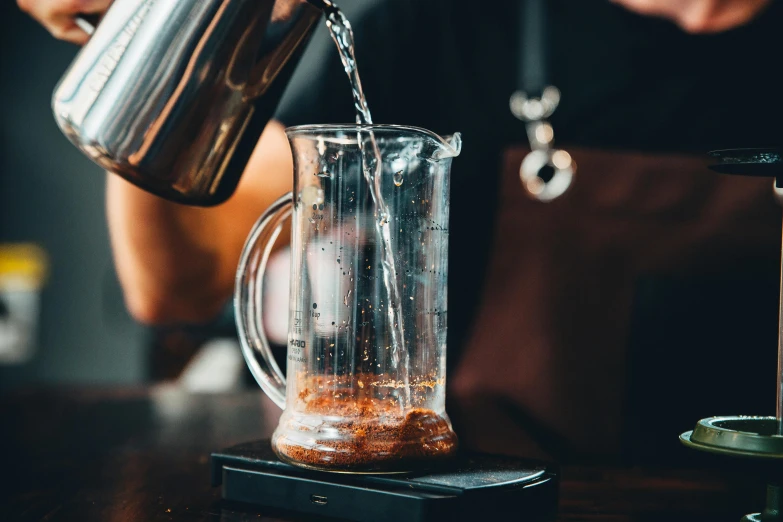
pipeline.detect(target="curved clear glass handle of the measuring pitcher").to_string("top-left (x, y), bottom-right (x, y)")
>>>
top-left (234, 192), bottom-right (294, 409)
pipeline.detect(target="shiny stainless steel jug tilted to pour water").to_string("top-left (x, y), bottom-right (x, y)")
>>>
top-left (52, 0), bottom-right (328, 206)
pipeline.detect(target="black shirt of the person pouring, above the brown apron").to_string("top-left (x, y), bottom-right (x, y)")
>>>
top-left (278, 0), bottom-right (783, 362)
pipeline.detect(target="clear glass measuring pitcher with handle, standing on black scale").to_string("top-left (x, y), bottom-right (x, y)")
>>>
top-left (235, 125), bottom-right (461, 471)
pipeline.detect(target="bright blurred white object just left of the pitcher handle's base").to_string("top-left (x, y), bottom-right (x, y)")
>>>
top-left (178, 339), bottom-right (245, 393)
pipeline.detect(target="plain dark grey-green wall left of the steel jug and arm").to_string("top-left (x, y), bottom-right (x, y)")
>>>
top-left (0, 4), bottom-right (146, 388)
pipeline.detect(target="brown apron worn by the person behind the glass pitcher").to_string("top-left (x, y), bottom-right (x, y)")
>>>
top-left (450, 148), bottom-right (781, 458)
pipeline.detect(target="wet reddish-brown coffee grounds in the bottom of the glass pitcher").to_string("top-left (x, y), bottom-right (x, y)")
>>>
top-left (274, 394), bottom-right (457, 471)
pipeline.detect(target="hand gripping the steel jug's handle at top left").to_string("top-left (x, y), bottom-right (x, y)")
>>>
top-left (16, 0), bottom-right (112, 45)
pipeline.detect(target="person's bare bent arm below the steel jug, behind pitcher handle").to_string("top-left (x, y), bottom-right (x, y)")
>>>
top-left (106, 121), bottom-right (293, 324)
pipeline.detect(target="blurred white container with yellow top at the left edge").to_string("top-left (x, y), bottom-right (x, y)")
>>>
top-left (0, 244), bottom-right (48, 364)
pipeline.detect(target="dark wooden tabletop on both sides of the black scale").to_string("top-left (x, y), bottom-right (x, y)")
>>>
top-left (0, 387), bottom-right (763, 522)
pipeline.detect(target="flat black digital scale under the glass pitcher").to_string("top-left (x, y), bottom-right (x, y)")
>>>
top-left (211, 440), bottom-right (558, 522)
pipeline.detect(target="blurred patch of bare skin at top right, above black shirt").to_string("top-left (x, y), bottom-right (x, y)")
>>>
top-left (611, 0), bottom-right (772, 33)
